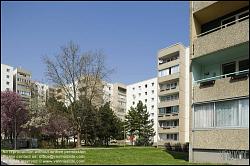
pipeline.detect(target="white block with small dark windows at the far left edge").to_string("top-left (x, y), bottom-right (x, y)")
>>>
top-left (1, 64), bottom-right (13, 91)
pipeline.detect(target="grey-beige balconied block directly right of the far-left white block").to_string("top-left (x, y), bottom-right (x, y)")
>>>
top-left (13, 67), bottom-right (31, 105)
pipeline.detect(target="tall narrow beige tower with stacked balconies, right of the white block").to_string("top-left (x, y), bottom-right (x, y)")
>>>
top-left (157, 43), bottom-right (189, 146)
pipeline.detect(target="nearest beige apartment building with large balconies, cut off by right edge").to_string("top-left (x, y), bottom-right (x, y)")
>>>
top-left (189, 1), bottom-right (249, 164)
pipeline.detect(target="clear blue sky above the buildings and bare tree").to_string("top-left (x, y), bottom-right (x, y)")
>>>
top-left (1, 1), bottom-right (189, 84)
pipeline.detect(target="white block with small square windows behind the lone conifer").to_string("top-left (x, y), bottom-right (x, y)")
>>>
top-left (126, 78), bottom-right (158, 145)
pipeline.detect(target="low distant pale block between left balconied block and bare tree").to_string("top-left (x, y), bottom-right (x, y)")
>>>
top-left (31, 81), bottom-right (49, 105)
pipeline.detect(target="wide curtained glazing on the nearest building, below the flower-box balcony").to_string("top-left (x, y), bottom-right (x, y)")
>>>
top-left (194, 98), bottom-right (249, 128)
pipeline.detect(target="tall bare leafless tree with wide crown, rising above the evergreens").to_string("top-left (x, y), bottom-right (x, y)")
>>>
top-left (44, 42), bottom-right (112, 147)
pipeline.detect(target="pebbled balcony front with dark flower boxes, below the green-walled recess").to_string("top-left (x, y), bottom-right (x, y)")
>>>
top-left (193, 70), bottom-right (249, 103)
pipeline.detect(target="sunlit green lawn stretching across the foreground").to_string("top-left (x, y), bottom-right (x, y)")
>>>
top-left (2, 147), bottom-right (211, 165)
